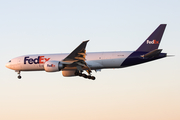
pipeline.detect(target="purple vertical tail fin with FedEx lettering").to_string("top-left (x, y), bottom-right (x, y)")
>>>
top-left (136, 24), bottom-right (166, 52)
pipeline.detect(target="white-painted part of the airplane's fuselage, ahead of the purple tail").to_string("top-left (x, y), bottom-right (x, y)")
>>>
top-left (6, 51), bottom-right (132, 71)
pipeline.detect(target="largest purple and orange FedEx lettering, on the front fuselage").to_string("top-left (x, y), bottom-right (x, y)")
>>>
top-left (24, 56), bottom-right (50, 64)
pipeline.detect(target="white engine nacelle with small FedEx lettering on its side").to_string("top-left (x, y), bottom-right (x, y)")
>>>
top-left (44, 60), bottom-right (64, 72)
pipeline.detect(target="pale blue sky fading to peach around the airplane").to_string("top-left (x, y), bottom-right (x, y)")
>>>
top-left (0, 0), bottom-right (180, 120)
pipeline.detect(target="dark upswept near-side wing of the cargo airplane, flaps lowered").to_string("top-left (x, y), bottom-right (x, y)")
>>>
top-left (62, 40), bottom-right (91, 74)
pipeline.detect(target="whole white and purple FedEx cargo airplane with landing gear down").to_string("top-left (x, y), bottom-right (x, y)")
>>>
top-left (6, 24), bottom-right (167, 80)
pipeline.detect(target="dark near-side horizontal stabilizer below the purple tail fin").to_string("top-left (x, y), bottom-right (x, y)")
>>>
top-left (141, 49), bottom-right (162, 59)
